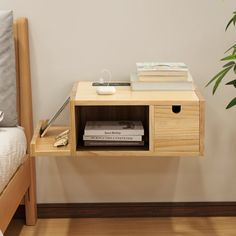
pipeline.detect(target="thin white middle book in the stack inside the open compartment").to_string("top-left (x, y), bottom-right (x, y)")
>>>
top-left (83, 135), bottom-right (142, 141)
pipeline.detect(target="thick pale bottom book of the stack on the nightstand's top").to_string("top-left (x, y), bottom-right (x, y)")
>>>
top-left (130, 73), bottom-right (195, 91)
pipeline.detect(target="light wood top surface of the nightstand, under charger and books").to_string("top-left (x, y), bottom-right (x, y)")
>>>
top-left (72, 81), bottom-right (199, 105)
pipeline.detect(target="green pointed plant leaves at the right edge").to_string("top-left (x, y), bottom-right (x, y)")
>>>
top-left (206, 11), bottom-right (236, 109)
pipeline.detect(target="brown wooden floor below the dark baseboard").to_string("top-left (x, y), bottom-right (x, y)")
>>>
top-left (4, 217), bottom-right (236, 236)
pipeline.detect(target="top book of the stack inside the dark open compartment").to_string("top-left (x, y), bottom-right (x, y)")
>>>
top-left (84, 121), bottom-right (144, 136)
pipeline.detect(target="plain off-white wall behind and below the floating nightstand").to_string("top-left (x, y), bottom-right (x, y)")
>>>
top-left (0, 0), bottom-right (236, 203)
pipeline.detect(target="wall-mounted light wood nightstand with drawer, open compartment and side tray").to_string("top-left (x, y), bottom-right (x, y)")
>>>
top-left (31, 81), bottom-right (205, 157)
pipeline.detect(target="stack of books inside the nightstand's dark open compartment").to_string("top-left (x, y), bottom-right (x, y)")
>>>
top-left (83, 121), bottom-right (144, 146)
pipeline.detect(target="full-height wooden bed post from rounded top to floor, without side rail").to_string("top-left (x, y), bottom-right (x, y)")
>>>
top-left (14, 18), bottom-right (37, 225)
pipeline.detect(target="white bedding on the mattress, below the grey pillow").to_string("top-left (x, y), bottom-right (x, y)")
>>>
top-left (0, 127), bottom-right (27, 193)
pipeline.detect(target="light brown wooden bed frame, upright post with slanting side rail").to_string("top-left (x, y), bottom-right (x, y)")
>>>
top-left (0, 18), bottom-right (37, 232)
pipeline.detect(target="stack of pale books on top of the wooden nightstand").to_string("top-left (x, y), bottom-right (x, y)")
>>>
top-left (130, 62), bottom-right (194, 91)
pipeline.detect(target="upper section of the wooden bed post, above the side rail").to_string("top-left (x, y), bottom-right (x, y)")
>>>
top-left (14, 18), bottom-right (33, 153)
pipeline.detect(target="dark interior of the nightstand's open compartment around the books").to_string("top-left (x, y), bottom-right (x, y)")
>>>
top-left (75, 105), bottom-right (149, 151)
